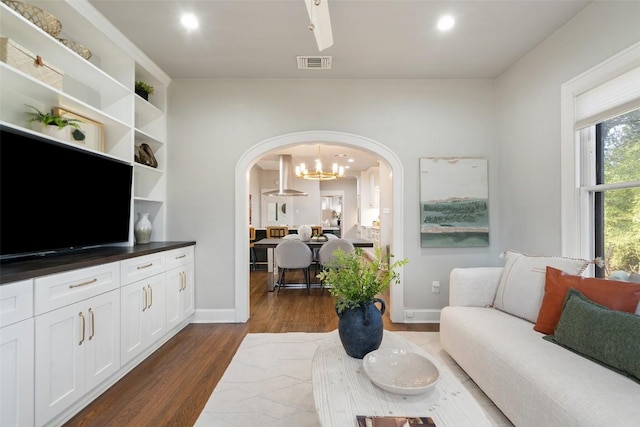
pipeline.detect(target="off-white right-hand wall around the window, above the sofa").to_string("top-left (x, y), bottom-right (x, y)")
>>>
top-left (493, 1), bottom-right (640, 255)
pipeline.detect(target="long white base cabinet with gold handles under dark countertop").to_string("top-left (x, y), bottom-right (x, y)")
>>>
top-left (0, 244), bottom-right (195, 427)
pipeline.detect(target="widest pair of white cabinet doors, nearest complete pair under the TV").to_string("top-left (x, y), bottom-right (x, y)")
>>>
top-left (35, 290), bottom-right (120, 425)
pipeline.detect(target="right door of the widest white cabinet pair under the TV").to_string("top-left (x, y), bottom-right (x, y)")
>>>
top-left (85, 290), bottom-right (120, 391)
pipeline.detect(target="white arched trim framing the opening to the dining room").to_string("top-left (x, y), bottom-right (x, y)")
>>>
top-left (234, 131), bottom-right (404, 323)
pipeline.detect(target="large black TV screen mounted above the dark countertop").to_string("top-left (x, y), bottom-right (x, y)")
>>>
top-left (0, 125), bottom-right (133, 259)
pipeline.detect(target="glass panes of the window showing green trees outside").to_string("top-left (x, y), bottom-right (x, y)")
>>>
top-left (583, 109), bottom-right (640, 280)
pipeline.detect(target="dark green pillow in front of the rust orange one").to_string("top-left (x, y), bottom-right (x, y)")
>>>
top-left (544, 288), bottom-right (640, 382)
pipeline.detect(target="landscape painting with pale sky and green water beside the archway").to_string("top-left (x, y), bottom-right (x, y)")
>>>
top-left (420, 157), bottom-right (489, 248)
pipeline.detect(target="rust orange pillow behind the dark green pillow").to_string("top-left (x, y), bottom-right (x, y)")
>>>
top-left (533, 267), bottom-right (640, 334)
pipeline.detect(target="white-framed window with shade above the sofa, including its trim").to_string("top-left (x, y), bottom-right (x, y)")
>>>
top-left (561, 43), bottom-right (640, 281)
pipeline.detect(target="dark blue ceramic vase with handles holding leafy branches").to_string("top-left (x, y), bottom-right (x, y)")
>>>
top-left (336, 298), bottom-right (386, 359)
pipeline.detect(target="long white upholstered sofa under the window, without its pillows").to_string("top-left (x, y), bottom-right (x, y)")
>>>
top-left (440, 267), bottom-right (640, 427)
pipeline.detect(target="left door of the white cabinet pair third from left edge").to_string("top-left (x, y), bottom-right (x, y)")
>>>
top-left (120, 282), bottom-right (148, 365)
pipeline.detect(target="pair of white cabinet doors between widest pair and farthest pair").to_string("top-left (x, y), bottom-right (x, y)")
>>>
top-left (120, 274), bottom-right (166, 365)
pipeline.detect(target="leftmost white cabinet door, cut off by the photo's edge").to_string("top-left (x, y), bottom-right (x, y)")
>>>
top-left (0, 318), bottom-right (34, 427)
